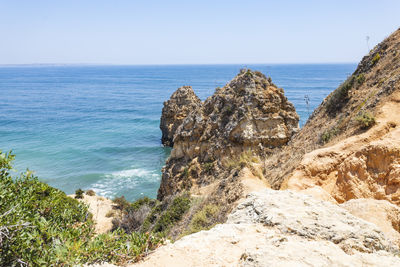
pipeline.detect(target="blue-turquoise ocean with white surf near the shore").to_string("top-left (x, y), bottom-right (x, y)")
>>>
top-left (0, 64), bottom-right (356, 200)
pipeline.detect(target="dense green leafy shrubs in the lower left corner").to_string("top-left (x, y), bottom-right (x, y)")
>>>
top-left (0, 151), bottom-right (162, 266)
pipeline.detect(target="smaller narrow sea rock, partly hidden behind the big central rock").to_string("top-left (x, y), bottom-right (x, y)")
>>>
top-left (160, 86), bottom-right (201, 147)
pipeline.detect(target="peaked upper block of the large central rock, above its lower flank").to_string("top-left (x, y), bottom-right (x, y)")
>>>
top-left (171, 70), bottom-right (299, 161)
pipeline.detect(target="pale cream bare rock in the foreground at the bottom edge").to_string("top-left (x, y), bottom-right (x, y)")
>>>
top-left (135, 190), bottom-right (400, 266)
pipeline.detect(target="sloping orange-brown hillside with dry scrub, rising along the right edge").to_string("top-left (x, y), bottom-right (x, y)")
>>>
top-left (265, 29), bottom-right (400, 191)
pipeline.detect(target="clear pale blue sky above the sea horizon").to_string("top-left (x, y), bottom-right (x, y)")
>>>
top-left (0, 0), bottom-right (400, 64)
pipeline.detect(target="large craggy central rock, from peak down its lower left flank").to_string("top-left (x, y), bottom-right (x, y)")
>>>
top-left (158, 70), bottom-right (299, 199)
